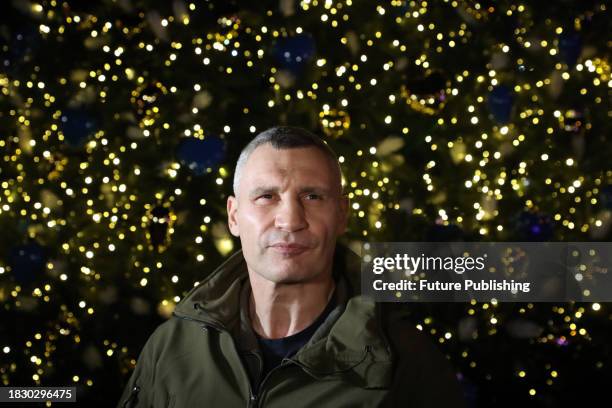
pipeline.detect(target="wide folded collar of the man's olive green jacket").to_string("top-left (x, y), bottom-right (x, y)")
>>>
top-left (173, 245), bottom-right (393, 388)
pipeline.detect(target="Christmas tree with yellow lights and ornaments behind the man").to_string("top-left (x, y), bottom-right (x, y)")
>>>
top-left (0, 0), bottom-right (612, 407)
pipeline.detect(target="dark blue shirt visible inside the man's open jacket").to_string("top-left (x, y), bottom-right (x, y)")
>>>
top-left (256, 295), bottom-right (336, 380)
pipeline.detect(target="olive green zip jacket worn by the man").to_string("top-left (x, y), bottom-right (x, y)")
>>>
top-left (118, 246), bottom-right (464, 408)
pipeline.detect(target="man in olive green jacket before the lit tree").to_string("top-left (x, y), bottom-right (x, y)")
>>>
top-left (119, 127), bottom-right (463, 408)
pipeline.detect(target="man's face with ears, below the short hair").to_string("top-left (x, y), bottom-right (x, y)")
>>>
top-left (227, 144), bottom-right (348, 283)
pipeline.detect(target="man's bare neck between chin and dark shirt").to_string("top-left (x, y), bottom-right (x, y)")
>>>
top-left (249, 274), bottom-right (336, 339)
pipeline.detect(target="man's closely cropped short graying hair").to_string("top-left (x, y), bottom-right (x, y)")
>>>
top-left (233, 126), bottom-right (342, 196)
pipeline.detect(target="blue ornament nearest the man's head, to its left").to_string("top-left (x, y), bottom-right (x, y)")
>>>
top-left (177, 136), bottom-right (226, 175)
